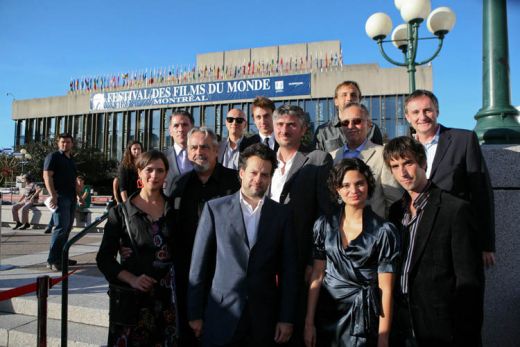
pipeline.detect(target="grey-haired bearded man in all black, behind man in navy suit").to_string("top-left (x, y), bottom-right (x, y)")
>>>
top-left (170, 127), bottom-right (240, 346)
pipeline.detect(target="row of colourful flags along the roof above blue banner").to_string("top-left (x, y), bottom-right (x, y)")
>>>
top-left (69, 52), bottom-right (343, 93)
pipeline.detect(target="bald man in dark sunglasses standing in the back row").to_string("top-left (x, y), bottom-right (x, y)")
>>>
top-left (218, 108), bottom-right (247, 170)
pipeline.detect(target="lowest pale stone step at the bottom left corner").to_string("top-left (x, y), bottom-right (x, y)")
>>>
top-left (0, 313), bottom-right (108, 347)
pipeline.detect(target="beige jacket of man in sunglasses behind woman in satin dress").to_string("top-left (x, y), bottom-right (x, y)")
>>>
top-left (330, 141), bottom-right (404, 218)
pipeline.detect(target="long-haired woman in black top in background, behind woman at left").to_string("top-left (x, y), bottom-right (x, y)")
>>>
top-left (118, 141), bottom-right (143, 202)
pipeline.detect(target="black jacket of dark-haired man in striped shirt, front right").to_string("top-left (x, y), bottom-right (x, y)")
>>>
top-left (390, 184), bottom-right (483, 346)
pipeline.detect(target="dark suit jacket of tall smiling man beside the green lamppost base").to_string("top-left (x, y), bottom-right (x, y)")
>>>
top-left (430, 125), bottom-right (495, 251)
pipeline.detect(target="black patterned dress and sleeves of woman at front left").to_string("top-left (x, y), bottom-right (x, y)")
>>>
top-left (96, 196), bottom-right (178, 347)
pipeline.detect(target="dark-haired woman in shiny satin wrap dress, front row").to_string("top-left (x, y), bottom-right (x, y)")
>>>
top-left (304, 159), bottom-right (400, 347)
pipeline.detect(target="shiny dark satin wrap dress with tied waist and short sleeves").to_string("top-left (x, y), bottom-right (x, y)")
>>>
top-left (314, 207), bottom-right (400, 347)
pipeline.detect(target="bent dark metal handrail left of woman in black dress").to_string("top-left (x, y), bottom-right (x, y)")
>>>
top-left (61, 206), bottom-right (109, 347)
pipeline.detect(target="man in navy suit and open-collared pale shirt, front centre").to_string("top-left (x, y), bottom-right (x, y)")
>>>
top-left (188, 144), bottom-right (297, 347)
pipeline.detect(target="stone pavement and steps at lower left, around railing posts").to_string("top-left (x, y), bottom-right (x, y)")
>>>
top-left (0, 224), bottom-right (108, 346)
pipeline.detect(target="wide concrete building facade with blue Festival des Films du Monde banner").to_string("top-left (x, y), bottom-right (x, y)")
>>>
top-left (12, 41), bottom-right (432, 159)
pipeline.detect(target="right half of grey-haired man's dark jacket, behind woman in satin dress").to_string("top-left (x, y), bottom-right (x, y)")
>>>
top-left (280, 147), bottom-right (334, 270)
